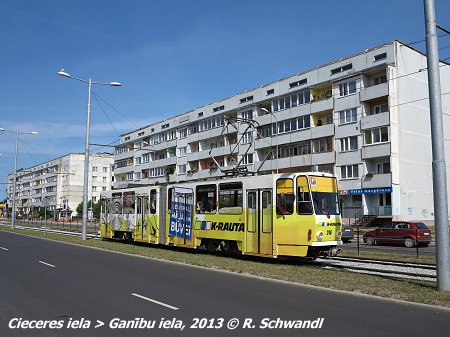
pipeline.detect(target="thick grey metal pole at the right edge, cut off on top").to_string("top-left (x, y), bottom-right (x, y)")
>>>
top-left (424, 0), bottom-right (450, 291)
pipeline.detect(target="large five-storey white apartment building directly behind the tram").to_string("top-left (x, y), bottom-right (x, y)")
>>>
top-left (114, 41), bottom-right (450, 221)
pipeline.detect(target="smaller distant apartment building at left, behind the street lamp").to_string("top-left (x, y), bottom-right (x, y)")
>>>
top-left (7, 153), bottom-right (114, 216)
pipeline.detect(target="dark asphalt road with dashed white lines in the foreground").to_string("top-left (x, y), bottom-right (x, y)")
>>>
top-left (0, 231), bottom-right (450, 337)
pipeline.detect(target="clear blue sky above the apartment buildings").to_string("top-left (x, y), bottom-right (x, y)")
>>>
top-left (0, 0), bottom-right (450, 196)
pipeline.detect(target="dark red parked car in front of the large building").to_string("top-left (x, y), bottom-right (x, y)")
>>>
top-left (363, 221), bottom-right (431, 248)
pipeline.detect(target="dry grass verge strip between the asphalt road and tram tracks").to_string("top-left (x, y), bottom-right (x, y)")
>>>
top-left (0, 227), bottom-right (450, 307)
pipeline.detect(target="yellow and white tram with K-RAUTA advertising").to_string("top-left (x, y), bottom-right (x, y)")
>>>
top-left (100, 172), bottom-right (342, 258)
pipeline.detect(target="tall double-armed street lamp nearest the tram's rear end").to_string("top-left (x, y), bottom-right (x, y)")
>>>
top-left (58, 69), bottom-right (121, 240)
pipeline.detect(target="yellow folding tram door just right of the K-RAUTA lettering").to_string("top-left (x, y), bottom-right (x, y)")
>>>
top-left (246, 189), bottom-right (273, 255)
